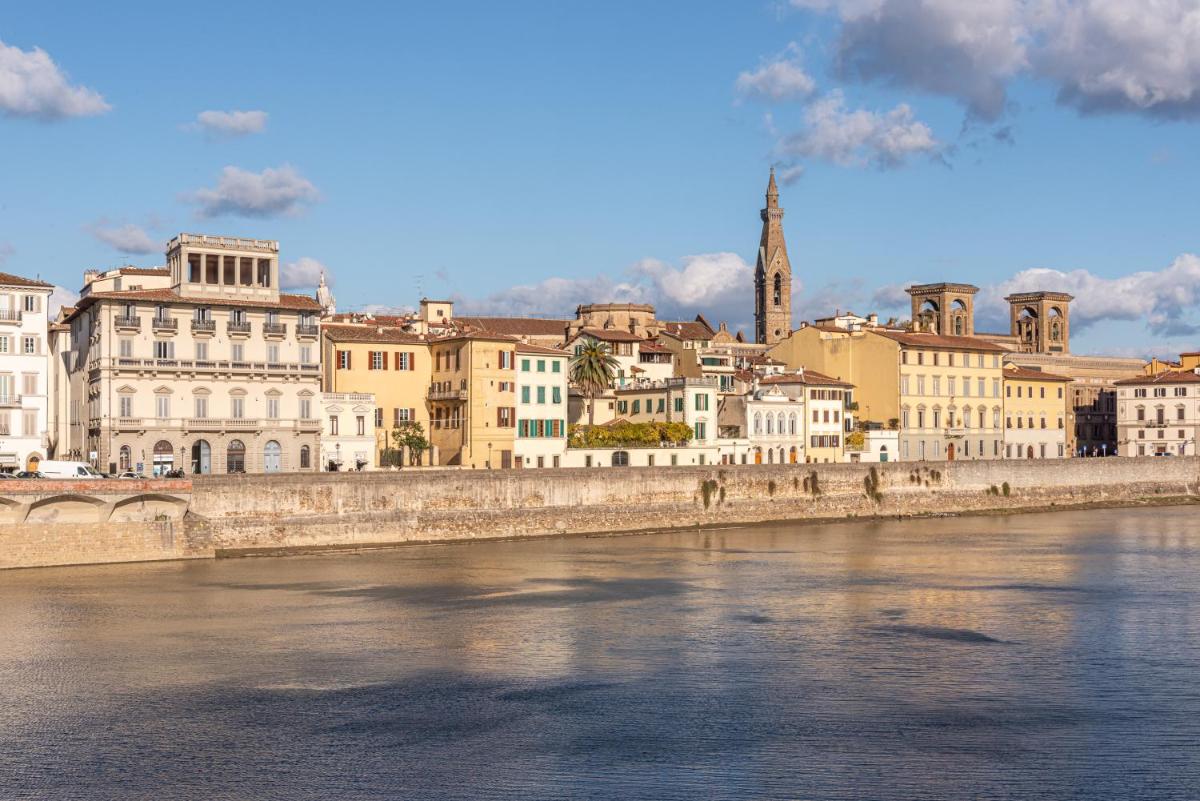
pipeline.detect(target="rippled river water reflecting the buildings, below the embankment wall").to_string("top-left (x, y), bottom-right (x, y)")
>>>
top-left (0, 507), bottom-right (1200, 801)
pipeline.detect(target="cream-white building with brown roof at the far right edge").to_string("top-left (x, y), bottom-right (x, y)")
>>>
top-left (1114, 367), bottom-right (1200, 456)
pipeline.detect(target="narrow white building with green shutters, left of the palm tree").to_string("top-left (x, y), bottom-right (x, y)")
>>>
top-left (512, 344), bottom-right (570, 468)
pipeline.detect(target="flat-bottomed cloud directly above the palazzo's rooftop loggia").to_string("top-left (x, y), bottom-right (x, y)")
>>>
top-left (192, 164), bottom-right (320, 217)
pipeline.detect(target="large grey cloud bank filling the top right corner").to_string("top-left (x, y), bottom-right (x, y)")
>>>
top-left (792, 0), bottom-right (1200, 120)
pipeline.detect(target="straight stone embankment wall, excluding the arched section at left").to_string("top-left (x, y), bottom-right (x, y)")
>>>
top-left (191, 458), bottom-right (1200, 554)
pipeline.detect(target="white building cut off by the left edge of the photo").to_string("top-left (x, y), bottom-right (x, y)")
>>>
top-left (0, 272), bottom-right (54, 472)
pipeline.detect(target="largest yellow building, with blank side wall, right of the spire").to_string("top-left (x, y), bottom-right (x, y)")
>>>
top-left (769, 325), bottom-right (1004, 460)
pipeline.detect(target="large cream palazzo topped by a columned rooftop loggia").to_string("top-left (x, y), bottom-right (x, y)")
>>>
top-left (62, 234), bottom-right (322, 475)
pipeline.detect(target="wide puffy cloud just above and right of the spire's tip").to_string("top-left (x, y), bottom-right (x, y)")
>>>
top-left (780, 89), bottom-right (942, 168)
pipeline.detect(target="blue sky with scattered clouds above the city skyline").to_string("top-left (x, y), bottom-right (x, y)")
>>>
top-left (0, 0), bottom-right (1200, 356)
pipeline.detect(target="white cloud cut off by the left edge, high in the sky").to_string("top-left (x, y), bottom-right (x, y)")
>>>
top-left (0, 42), bottom-right (110, 120)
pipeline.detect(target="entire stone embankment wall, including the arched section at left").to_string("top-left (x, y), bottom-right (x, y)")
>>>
top-left (0, 458), bottom-right (1200, 567)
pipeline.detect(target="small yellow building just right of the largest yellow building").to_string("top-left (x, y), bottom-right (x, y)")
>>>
top-left (1004, 365), bottom-right (1073, 459)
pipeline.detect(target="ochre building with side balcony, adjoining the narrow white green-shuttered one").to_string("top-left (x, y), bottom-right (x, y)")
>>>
top-left (426, 332), bottom-right (517, 469)
